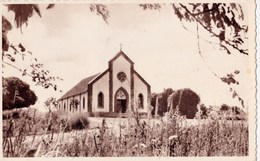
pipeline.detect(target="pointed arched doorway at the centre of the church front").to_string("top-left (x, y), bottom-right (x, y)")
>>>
top-left (114, 87), bottom-right (128, 113)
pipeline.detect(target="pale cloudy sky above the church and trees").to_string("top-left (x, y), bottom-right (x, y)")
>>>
top-left (2, 4), bottom-right (252, 109)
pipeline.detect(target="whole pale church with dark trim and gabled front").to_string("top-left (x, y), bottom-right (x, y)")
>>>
top-left (58, 51), bottom-right (151, 114)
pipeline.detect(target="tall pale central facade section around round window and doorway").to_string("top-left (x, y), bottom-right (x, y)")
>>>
top-left (112, 55), bottom-right (131, 112)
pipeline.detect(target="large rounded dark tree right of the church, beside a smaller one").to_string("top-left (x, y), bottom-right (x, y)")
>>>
top-left (168, 88), bottom-right (200, 119)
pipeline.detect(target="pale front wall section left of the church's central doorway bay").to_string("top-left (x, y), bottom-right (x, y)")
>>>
top-left (92, 72), bottom-right (109, 112)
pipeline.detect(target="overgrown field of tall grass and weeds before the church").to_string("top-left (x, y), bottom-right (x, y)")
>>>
top-left (3, 111), bottom-right (248, 157)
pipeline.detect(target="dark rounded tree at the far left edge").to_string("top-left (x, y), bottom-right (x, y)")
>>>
top-left (2, 77), bottom-right (37, 110)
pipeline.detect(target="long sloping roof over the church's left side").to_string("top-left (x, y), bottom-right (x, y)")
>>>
top-left (59, 73), bottom-right (100, 100)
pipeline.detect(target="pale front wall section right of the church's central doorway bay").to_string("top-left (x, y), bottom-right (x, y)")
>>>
top-left (134, 73), bottom-right (149, 112)
